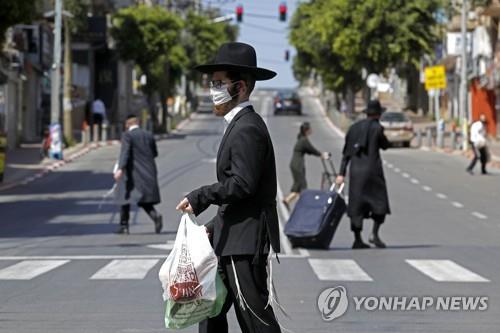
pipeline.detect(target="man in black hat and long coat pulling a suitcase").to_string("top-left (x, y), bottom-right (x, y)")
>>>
top-left (336, 100), bottom-right (391, 249)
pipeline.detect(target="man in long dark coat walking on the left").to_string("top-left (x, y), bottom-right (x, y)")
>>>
top-left (114, 115), bottom-right (163, 234)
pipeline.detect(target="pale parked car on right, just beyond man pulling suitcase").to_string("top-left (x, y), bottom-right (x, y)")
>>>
top-left (380, 111), bottom-right (414, 147)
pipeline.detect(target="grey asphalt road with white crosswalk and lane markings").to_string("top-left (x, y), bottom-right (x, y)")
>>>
top-left (0, 91), bottom-right (500, 333)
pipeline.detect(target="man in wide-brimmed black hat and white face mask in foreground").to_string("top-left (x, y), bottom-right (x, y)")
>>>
top-left (177, 43), bottom-right (280, 333)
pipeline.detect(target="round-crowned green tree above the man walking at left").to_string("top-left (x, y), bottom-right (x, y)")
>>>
top-left (111, 5), bottom-right (186, 130)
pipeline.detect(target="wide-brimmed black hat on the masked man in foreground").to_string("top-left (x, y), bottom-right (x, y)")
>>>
top-left (195, 42), bottom-right (276, 81)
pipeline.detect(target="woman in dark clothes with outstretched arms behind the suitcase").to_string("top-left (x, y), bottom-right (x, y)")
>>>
top-left (283, 122), bottom-right (330, 210)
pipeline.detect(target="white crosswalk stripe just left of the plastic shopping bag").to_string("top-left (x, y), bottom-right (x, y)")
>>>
top-left (90, 259), bottom-right (159, 280)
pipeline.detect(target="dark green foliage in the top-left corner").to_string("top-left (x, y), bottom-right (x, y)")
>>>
top-left (0, 0), bottom-right (36, 46)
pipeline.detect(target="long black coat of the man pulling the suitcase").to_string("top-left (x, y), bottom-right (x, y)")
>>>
top-left (340, 119), bottom-right (391, 217)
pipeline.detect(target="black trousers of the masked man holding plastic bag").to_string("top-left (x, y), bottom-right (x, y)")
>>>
top-left (199, 255), bottom-right (281, 333)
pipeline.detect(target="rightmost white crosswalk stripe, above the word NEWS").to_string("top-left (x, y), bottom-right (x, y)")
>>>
top-left (406, 259), bottom-right (489, 282)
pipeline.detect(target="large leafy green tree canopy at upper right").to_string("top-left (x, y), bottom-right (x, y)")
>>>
top-left (290, 0), bottom-right (441, 92)
